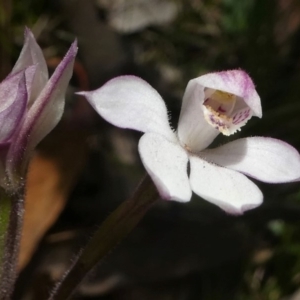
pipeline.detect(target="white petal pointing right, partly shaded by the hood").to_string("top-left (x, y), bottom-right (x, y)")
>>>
top-left (201, 137), bottom-right (300, 183)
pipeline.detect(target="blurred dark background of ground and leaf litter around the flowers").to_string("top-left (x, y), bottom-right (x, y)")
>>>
top-left (0, 0), bottom-right (300, 300)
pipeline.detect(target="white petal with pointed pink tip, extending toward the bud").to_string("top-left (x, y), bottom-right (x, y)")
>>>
top-left (79, 76), bottom-right (176, 141)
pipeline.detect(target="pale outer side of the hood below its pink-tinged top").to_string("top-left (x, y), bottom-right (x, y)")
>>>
top-left (178, 79), bottom-right (220, 152)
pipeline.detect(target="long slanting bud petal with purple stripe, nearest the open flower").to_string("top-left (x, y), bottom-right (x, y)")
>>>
top-left (7, 42), bottom-right (77, 178)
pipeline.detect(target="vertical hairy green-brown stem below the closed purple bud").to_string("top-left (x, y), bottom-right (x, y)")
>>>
top-left (0, 189), bottom-right (24, 300)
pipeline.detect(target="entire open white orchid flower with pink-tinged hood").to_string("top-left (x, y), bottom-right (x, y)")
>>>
top-left (81, 70), bottom-right (300, 214)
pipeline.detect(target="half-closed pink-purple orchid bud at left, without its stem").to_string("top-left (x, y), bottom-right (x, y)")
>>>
top-left (0, 29), bottom-right (77, 190)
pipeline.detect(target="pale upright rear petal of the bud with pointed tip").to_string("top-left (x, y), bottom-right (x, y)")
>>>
top-left (11, 28), bottom-right (49, 103)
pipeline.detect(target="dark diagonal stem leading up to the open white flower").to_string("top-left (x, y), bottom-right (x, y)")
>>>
top-left (49, 175), bottom-right (159, 300)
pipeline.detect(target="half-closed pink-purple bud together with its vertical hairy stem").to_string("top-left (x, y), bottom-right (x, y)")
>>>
top-left (0, 29), bottom-right (77, 299)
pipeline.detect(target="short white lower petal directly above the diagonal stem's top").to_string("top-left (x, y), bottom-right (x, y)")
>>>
top-left (139, 133), bottom-right (192, 202)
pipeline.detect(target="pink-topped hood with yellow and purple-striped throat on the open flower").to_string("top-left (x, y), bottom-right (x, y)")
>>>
top-left (178, 70), bottom-right (262, 153)
